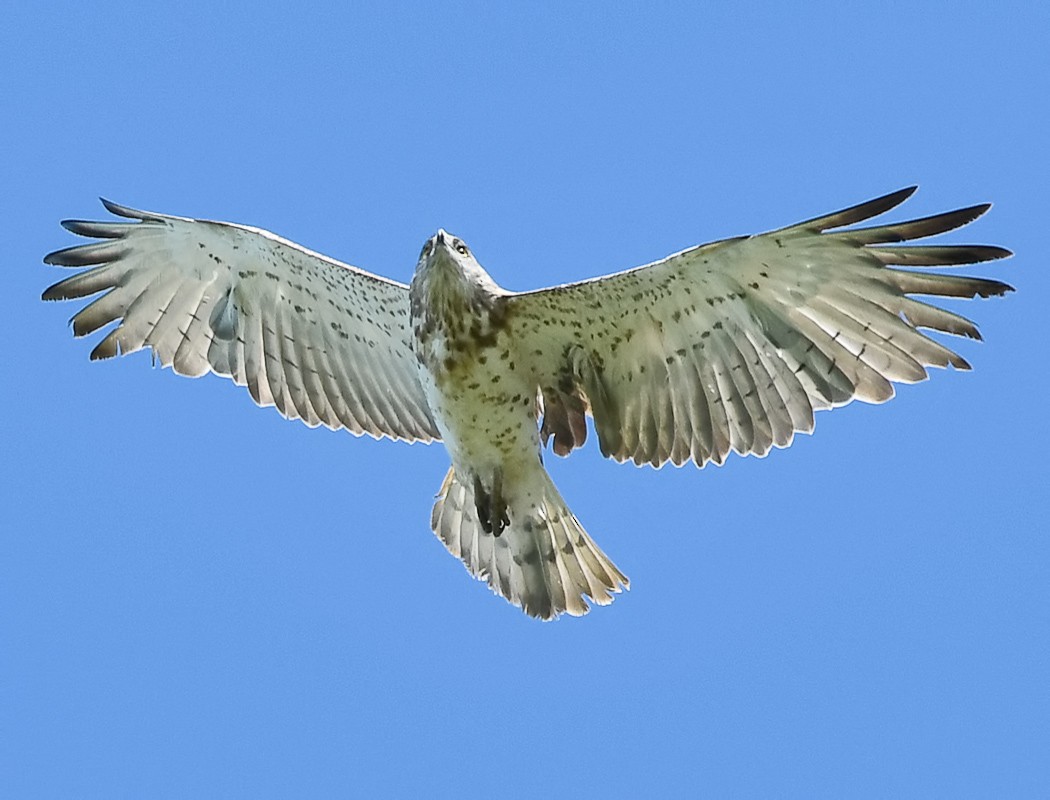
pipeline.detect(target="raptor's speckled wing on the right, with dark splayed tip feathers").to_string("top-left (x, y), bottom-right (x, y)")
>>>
top-left (507, 188), bottom-right (1010, 466)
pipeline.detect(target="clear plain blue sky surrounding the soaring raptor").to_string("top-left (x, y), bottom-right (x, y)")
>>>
top-left (0, 2), bottom-right (1050, 798)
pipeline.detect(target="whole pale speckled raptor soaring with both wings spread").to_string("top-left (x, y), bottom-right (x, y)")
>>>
top-left (43, 187), bottom-right (1011, 619)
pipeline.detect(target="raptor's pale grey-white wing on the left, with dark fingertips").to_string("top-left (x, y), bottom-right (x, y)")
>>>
top-left (43, 201), bottom-right (438, 441)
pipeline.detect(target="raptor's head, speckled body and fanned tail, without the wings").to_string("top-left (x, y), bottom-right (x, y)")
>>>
top-left (408, 231), bottom-right (627, 618)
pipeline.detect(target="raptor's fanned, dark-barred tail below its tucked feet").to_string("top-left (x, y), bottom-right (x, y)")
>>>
top-left (431, 469), bottom-right (629, 619)
